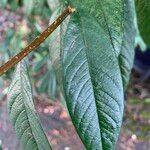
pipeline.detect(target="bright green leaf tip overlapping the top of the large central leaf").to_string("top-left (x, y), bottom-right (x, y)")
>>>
top-left (68, 0), bottom-right (124, 56)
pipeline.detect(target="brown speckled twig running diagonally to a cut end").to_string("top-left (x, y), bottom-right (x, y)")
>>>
top-left (0, 6), bottom-right (75, 76)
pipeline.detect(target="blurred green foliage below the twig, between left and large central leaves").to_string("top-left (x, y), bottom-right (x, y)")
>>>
top-left (32, 46), bottom-right (57, 99)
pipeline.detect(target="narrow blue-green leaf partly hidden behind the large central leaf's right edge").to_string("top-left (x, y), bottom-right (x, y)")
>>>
top-left (119, 0), bottom-right (135, 89)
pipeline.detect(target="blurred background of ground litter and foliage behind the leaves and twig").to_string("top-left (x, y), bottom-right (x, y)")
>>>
top-left (0, 0), bottom-right (150, 150)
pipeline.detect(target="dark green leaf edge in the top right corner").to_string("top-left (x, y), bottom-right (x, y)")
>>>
top-left (135, 0), bottom-right (150, 46)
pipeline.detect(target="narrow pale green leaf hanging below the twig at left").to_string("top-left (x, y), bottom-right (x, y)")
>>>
top-left (8, 61), bottom-right (51, 150)
